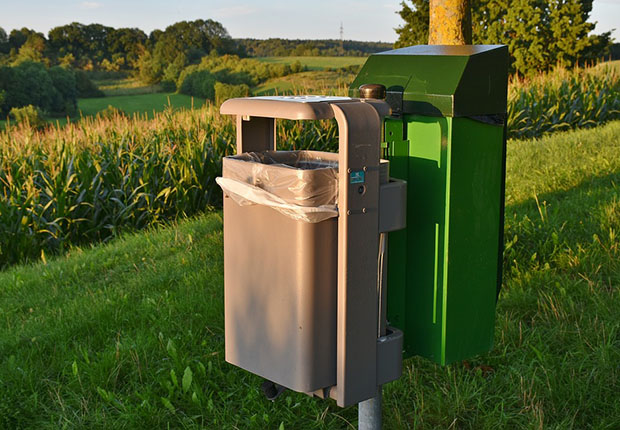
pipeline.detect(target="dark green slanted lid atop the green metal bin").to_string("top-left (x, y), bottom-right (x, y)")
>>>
top-left (349, 45), bottom-right (508, 117)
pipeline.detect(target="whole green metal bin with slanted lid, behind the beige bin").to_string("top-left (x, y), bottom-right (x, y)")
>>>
top-left (350, 45), bottom-right (508, 364)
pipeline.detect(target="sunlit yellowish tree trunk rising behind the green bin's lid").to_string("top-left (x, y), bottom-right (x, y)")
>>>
top-left (428, 0), bottom-right (471, 45)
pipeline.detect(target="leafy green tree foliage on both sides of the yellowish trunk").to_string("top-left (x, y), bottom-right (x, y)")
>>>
top-left (395, 0), bottom-right (612, 75)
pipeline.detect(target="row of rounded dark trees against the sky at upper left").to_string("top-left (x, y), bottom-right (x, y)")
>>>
top-left (0, 20), bottom-right (236, 71)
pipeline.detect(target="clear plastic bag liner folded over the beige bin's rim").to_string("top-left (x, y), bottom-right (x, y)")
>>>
top-left (216, 151), bottom-right (338, 223)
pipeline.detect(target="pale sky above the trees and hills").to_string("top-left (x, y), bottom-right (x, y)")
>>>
top-left (0, 0), bottom-right (620, 42)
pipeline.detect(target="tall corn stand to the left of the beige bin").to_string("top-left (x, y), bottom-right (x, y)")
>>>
top-left (0, 109), bottom-right (234, 265)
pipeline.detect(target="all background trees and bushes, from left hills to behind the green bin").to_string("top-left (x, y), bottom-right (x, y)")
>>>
top-left (0, 0), bottom-right (618, 119)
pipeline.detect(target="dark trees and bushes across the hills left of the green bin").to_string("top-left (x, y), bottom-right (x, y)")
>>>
top-left (0, 19), bottom-right (391, 119)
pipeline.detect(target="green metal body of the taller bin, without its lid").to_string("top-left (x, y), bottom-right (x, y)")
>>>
top-left (385, 115), bottom-right (504, 364)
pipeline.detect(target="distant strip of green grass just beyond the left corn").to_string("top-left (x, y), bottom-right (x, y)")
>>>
top-left (78, 93), bottom-right (205, 118)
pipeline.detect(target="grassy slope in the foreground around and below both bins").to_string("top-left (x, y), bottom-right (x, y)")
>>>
top-left (0, 122), bottom-right (620, 429)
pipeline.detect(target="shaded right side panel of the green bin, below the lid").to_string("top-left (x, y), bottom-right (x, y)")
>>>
top-left (444, 118), bottom-right (504, 362)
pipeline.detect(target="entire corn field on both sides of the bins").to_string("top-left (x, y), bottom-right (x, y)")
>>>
top-left (0, 63), bottom-right (620, 267)
